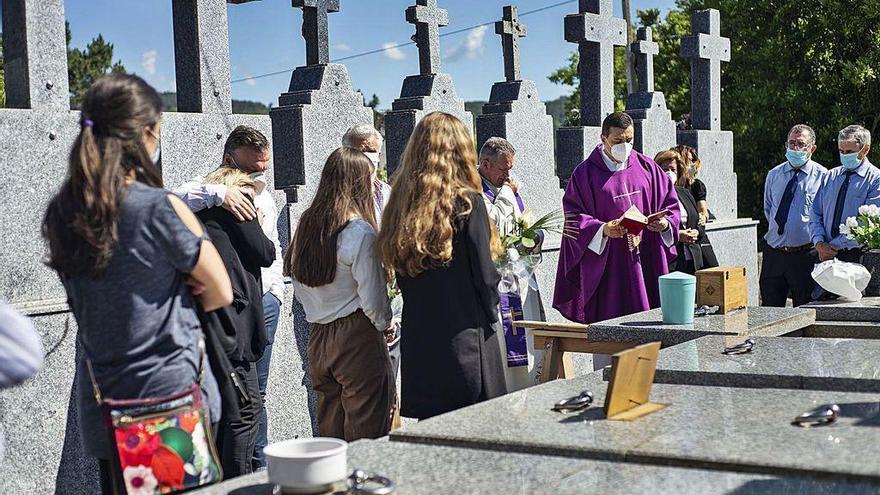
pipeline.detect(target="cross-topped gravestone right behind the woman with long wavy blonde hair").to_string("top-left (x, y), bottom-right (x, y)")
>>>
top-left (385, 0), bottom-right (474, 175)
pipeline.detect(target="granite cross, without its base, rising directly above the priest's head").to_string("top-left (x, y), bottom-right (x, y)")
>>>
top-left (565, 0), bottom-right (627, 127)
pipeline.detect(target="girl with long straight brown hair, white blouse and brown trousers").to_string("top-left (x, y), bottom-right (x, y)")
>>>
top-left (284, 148), bottom-right (394, 441)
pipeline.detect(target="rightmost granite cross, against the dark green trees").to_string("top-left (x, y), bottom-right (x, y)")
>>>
top-left (681, 9), bottom-right (730, 131)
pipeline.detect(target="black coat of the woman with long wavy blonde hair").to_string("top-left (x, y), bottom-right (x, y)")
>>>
top-left (397, 193), bottom-right (507, 419)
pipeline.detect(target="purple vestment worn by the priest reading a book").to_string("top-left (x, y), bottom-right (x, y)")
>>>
top-left (553, 144), bottom-right (680, 323)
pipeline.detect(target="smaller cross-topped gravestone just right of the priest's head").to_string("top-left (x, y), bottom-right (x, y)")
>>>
top-left (626, 27), bottom-right (676, 158)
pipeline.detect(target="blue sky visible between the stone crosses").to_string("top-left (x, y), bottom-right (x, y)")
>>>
top-left (56, 0), bottom-right (674, 108)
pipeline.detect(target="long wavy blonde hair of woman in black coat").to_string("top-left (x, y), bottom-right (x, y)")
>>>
top-left (377, 112), bottom-right (501, 277)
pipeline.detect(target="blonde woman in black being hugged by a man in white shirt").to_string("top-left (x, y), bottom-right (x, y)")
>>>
top-left (197, 167), bottom-right (275, 478)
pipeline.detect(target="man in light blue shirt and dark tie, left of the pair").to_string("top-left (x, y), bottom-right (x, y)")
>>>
top-left (760, 124), bottom-right (828, 307)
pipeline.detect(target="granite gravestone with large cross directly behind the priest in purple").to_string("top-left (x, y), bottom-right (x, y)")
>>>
top-left (556, 0), bottom-right (626, 187)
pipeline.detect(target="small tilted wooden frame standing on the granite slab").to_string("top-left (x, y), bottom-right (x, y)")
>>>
top-left (605, 342), bottom-right (666, 421)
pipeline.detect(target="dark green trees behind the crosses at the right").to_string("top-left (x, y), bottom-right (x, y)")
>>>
top-left (550, 0), bottom-right (880, 240)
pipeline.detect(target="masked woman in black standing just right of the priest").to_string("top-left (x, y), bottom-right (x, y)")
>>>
top-left (654, 150), bottom-right (718, 275)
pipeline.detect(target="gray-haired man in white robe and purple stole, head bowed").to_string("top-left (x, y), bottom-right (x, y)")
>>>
top-left (479, 137), bottom-right (545, 392)
